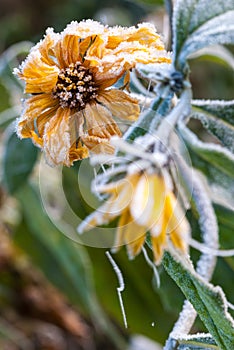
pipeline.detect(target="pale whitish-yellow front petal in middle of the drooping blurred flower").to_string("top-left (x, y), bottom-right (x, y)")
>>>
top-left (130, 173), bottom-right (165, 229)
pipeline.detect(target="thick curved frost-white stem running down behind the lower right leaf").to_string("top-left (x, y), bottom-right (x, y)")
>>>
top-left (165, 157), bottom-right (219, 350)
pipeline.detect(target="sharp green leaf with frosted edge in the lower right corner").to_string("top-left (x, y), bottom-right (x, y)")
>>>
top-left (163, 252), bottom-right (234, 350)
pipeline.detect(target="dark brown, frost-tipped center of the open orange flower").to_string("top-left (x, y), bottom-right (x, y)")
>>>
top-left (53, 62), bottom-right (98, 110)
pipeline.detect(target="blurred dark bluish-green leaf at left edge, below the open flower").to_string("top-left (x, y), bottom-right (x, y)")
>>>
top-left (3, 132), bottom-right (38, 193)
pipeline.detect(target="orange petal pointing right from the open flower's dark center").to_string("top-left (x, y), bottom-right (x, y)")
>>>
top-left (97, 89), bottom-right (140, 120)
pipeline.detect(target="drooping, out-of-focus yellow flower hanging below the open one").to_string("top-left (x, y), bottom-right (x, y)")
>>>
top-left (78, 173), bottom-right (190, 264)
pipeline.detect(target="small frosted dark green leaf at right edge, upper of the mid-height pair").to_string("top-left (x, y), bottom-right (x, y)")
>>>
top-left (192, 110), bottom-right (234, 152)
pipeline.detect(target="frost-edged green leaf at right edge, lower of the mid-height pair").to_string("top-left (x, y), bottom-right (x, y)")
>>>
top-left (178, 122), bottom-right (234, 178)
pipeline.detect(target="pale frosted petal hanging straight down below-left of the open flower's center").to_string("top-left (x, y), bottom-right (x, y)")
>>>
top-left (43, 107), bottom-right (71, 166)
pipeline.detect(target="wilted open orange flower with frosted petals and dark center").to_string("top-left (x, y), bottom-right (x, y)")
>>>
top-left (15, 20), bottom-right (170, 166)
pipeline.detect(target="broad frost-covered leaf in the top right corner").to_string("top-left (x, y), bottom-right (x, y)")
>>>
top-left (173, 0), bottom-right (234, 70)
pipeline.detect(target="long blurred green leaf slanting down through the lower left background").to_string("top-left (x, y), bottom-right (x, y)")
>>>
top-left (14, 184), bottom-right (126, 350)
